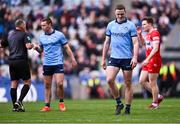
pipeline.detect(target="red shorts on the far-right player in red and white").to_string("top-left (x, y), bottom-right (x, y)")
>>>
top-left (142, 57), bottom-right (162, 73)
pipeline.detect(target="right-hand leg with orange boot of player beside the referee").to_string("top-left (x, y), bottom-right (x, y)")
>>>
top-left (54, 73), bottom-right (66, 112)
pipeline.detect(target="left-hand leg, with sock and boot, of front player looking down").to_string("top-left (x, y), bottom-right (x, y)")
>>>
top-left (106, 66), bottom-right (124, 115)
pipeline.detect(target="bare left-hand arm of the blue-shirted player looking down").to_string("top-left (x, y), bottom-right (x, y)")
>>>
top-left (101, 36), bottom-right (110, 69)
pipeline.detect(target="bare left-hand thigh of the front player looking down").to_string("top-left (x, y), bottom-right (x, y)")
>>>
top-left (106, 66), bottom-right (120, 82)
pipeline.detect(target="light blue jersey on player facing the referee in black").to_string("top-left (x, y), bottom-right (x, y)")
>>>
top-left (39, 30), bottom-right (67, 65)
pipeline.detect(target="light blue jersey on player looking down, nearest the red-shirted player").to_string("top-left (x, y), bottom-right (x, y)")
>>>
top-left (106, 20), bottom-right (137, 59)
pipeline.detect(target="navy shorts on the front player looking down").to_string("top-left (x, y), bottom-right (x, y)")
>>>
top-left (108, 58), bottom-right (132, 70)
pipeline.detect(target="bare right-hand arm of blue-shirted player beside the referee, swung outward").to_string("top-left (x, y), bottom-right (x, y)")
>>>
top-left (64, 43), bottom-right (77, 68)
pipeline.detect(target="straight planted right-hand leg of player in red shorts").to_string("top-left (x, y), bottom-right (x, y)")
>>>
top-left (149, 73), bottom-right (159, 109)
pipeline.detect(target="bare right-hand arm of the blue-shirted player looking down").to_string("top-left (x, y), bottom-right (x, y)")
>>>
top-left (131, 37), bottom-right (139, 68)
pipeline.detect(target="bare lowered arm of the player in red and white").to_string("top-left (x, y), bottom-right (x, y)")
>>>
top-left (142, 42), bottom-right (159, 66)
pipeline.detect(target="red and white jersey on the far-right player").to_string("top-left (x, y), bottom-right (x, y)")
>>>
top-left (145, 29), bottom-right (161, 57)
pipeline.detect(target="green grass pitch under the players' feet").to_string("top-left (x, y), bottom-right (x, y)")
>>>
top-left (0, 98), bottom-right (180, 124)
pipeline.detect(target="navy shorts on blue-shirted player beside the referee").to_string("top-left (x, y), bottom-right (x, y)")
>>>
top-left (43, 64), bottom-right (64, 76)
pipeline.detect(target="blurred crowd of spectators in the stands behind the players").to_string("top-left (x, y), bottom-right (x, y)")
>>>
top-left (0, 0), bottom-right (179, 97)
